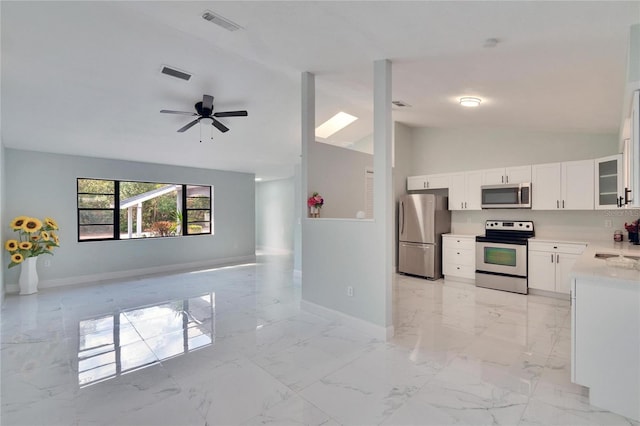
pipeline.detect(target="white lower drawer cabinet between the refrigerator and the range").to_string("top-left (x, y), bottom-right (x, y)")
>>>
top-left (442, 234), bottom-right (476, 280)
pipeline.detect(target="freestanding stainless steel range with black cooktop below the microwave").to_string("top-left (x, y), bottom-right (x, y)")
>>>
top-left (476, 220), bottom-right (535, 294)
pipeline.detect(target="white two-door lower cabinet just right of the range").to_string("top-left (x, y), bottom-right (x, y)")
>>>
top-left (528, 241), bottom-right (586, 294)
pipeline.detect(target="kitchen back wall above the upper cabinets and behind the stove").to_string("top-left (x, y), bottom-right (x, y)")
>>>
top-left (404, 128), bottom-right (624, 242)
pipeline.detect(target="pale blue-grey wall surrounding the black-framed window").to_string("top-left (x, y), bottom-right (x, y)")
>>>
top-left (4, 149), bottom-right (255, 287)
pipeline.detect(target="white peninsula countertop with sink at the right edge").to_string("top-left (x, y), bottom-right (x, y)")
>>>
top-left (571, 241), bottom-right (640, 289)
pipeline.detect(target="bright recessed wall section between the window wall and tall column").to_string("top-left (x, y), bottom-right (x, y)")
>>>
top-left (256, 178), bottom-right (295, 252)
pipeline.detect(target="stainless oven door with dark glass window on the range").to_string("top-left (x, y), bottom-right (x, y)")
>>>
top-left (476, 240), bottom-right (527, 278)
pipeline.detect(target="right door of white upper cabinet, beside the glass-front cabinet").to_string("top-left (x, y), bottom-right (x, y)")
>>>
top-left (560, 160), bottom-right (594, 210)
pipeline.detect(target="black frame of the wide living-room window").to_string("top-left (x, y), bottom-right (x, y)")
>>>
top-left (76, 177), bottom-right (214, 243)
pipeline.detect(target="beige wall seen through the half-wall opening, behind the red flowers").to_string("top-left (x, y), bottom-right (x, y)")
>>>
top-left (305, 142), bottom-right (373, 218)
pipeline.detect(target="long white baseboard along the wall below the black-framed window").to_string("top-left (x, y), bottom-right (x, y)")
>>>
top-left (5, 255), bottom-right (256, 293)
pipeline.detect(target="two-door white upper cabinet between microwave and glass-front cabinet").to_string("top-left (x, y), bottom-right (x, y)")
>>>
top-left (531, 160), bottom-right (594, 210)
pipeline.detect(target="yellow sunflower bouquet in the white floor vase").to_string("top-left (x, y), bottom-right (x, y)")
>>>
top-left (4, 216), bottom-right (60, 268)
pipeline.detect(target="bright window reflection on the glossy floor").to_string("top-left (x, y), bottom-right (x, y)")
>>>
top-left (78, 293), bottom-right (215, 387)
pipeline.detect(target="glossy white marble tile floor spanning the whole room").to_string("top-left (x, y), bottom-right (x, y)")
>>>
top-left (0, 256), bottom-right (638, 426)
